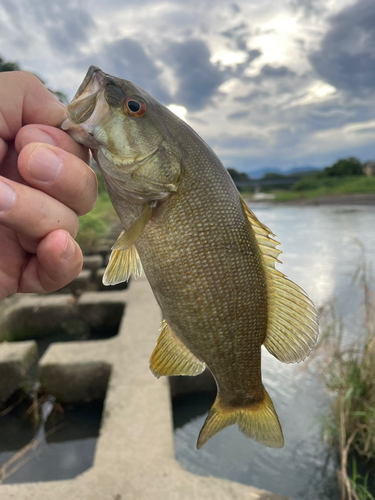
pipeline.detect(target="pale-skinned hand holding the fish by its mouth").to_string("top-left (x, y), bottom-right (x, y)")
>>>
top-left (0, 72), bottom-right (97, 300)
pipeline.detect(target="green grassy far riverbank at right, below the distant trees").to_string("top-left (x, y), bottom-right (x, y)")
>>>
top-left (275, 175), bottom-right (375, 202)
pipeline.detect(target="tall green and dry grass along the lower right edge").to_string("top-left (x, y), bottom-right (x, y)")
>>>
top-left (315, 244), bottom-right (375, 500)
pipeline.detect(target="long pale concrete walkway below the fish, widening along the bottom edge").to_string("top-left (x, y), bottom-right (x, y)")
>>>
top-left (0, 278), bottom-right (285, 500)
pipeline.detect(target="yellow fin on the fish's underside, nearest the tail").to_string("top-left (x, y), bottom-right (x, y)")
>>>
top-left (150, 320), bottom-right (206, 378)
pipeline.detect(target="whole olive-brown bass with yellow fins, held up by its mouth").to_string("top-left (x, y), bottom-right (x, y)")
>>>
top-left (61, 66), bottom-right (318, 448)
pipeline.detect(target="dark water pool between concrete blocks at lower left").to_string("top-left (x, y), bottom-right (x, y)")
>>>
top-left (0, 393), bottom-right (103, 488)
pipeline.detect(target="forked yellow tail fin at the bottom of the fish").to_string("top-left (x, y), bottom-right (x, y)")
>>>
top-left (197, 389), bottom-right (284, 449)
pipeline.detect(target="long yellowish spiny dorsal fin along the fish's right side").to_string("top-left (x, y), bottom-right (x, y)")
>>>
top-left (241, 198), bottom-right (318, 363)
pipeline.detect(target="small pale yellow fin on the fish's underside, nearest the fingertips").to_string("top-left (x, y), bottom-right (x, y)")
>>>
top-left (103, 243), bottom-right (142, 286)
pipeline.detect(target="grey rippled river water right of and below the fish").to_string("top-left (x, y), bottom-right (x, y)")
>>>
top-left (174, 205), bottom-right (375, 500)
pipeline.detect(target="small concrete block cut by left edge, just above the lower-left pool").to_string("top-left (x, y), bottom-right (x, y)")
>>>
top-left (0, 340), bottom-right (37, 401)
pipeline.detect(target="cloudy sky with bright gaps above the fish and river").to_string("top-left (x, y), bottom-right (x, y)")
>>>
top-left (0, 0), bottom-right (375, 175)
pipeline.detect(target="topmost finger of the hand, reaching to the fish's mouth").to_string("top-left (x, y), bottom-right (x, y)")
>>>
top-left (0, 71), bottom-right (65, 141)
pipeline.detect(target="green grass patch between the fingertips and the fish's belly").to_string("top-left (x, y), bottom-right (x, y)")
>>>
top-left (76, 174), bottom-right (117, 253)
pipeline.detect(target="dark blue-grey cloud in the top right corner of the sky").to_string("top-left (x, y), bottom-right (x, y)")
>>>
top-left (310, 0), bottom-right (375, 95)
